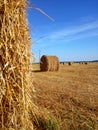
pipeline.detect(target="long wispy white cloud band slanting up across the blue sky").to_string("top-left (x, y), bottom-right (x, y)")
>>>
top-left (34, 20), bottom-right (98, 48)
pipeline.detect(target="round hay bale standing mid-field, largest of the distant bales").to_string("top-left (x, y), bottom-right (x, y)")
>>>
top-left (40, 55), bottom-right (59, 71)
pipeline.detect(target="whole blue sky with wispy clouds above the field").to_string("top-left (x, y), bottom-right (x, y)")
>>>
top-left (28, 0), bottom-right (98, 62)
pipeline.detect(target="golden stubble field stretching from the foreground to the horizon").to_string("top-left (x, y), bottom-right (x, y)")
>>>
top-left (32, 63), bottom-right (98, 130)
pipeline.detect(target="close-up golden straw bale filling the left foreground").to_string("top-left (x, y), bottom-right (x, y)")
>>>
top-left (0, 0), bottom-right (34, 130)
